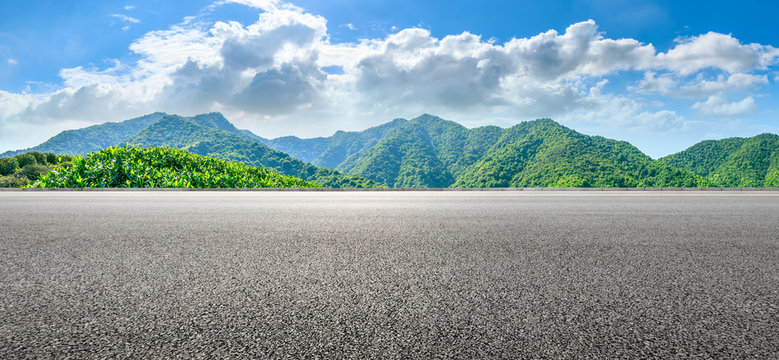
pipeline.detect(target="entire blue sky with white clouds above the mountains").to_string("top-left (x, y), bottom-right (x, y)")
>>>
top-left (0, 0), bottom-right (779, 157)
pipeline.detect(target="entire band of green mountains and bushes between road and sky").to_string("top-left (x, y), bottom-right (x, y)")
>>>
top-left (0, 113), bottom-right (779, 188)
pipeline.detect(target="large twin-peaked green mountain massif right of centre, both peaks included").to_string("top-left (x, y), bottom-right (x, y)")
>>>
top-left (338, 114), bottom-right (708, 188)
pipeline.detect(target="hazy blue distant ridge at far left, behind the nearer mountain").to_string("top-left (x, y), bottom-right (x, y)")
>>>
top-left (0, 112), bottom-right (166, 157)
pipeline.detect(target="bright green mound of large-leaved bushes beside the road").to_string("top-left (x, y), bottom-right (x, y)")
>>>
top-left (30, 147), bottom-right (319, 188)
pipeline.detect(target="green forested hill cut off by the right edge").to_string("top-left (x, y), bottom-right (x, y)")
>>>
top-left (659, 134), bottom-right (779, 187)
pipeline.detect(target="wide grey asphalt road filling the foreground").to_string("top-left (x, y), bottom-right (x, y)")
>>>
top-left (0, 192), bottom-right (779, 359)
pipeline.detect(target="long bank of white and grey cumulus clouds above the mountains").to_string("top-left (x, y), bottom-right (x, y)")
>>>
top-left (0, 0), bottom-right (779, 150)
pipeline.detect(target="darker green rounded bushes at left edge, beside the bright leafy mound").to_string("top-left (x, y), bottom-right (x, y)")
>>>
top-left (0, 151), bottom-right (72, 187)
